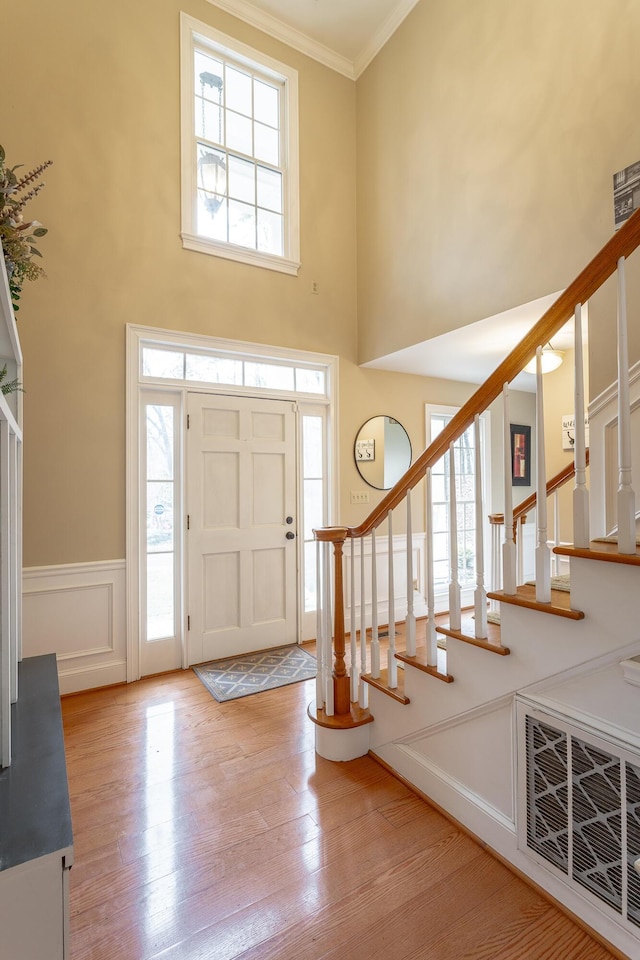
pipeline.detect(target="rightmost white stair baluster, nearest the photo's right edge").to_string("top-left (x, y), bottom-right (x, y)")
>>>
top-left (617, 257), bottom-right (636, 553)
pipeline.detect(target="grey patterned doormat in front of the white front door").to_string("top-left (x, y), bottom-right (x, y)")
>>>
top-left (193, 644), bottom-right (317, 703)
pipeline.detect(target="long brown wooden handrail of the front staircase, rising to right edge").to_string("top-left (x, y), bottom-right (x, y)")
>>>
top-left (347, 210), bottom-right (640, 537)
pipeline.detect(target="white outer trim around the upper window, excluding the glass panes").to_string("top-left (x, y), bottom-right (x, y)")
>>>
top-left (180, 13), bottom-right (300, 276)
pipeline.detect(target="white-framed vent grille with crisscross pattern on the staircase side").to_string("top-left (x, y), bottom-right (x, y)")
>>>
top-left (520, 714), bottom-right (640, 927)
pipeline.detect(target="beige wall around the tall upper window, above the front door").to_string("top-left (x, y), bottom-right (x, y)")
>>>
top-left (0, 0), bottom-right (356, 566)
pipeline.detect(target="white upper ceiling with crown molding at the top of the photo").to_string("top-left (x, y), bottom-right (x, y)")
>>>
top-left (209, 0), bottom-right (418, 79)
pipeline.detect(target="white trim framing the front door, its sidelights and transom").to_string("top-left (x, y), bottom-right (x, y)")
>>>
top-left (125, 324), bottom-right (339, 683)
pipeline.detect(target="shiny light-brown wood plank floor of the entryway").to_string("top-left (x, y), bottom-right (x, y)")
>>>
top-left (62, 670), bottom-right (612, 960)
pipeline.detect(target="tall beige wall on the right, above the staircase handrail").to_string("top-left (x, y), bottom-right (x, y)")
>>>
top-left (357, 0), bottom-right (640, 389)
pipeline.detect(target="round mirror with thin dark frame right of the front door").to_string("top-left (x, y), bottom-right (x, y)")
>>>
top-left (353, 416), bottom-right (411, 490)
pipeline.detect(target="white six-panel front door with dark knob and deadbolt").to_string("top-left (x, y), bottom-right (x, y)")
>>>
top-left (187, 393), bottom-right (297, 664)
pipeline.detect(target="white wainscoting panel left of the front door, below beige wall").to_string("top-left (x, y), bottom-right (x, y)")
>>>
top-left (22, 560), bottom-right (127, 693)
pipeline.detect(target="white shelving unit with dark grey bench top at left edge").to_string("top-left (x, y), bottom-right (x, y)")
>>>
top-left (0, 248), bottom-right (73, 960)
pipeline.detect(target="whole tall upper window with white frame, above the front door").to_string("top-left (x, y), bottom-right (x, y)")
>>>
top-left (181, 14), bottom-right (299, 273)
